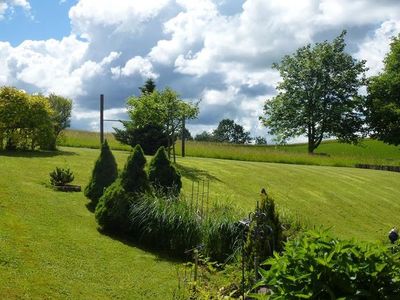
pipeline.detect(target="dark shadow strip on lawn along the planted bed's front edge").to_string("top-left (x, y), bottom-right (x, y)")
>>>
top-left (97, 228), bottom-right (187, 263)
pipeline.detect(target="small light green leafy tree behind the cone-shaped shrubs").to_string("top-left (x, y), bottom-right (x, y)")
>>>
top-left (127, 88), bottom-right (199, 161)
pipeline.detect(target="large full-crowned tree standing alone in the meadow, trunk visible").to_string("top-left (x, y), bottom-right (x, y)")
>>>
top-left (260, 31), bottom-right (366, 153)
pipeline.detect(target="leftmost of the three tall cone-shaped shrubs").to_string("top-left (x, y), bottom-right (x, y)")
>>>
top-left (84, 140), bottom-right (118, 207)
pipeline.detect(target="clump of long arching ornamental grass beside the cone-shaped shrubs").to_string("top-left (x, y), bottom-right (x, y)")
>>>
top-left (130, 194), bottom-right (201, 257)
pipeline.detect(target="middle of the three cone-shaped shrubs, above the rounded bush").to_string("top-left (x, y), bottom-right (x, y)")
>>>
top-left (121, 145), bottom-right (149, 194)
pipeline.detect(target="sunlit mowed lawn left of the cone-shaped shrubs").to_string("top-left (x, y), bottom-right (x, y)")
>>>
top-left (0, 149), bottom-right (177, 299)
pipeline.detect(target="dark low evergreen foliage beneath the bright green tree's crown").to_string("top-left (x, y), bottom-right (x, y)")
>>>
top-left (114, 122), bottom-right (168, 155)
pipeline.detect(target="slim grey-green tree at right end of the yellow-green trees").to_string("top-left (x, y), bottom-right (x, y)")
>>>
top-left (47, 94), bottom-right (72, 150)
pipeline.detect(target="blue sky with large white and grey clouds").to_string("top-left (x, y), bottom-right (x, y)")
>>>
top-left (0, 0), bottom-right (400, 136)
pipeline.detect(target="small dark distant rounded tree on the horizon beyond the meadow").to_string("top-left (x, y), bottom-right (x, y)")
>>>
top-left (213, 119), bottom-right (251, 144)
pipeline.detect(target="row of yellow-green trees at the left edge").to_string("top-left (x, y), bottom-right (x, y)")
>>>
top-left (0, 87), bottom-right (72, 150)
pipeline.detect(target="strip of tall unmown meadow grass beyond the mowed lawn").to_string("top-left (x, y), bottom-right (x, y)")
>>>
top-left (60, 130), bottom-right (400, 167)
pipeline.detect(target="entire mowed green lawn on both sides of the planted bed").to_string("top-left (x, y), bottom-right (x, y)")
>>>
top-left (0, 147), bottom-right (400, 299)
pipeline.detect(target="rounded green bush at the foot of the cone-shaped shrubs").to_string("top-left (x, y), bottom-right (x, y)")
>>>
top-left (95, 179), bottom-right (133, 233)
